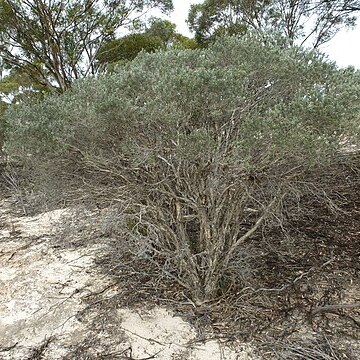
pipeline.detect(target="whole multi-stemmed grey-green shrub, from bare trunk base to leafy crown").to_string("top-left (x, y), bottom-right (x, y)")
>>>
top-left (6, 34), bottom-right (360, 302)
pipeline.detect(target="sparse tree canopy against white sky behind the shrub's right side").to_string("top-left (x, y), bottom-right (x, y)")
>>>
top-left (188, 0), bottom-right (360, 48)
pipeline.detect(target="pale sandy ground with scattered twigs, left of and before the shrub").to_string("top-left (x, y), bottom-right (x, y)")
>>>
top-left (0, 201), bottom-right (255, 360)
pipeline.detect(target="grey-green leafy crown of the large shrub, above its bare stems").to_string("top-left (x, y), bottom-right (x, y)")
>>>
top-left (8, 36), bottom-right (359, 160)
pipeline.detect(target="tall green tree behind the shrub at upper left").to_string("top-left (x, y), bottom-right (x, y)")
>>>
top-left (0, 0), bottom-right (173, 92)
